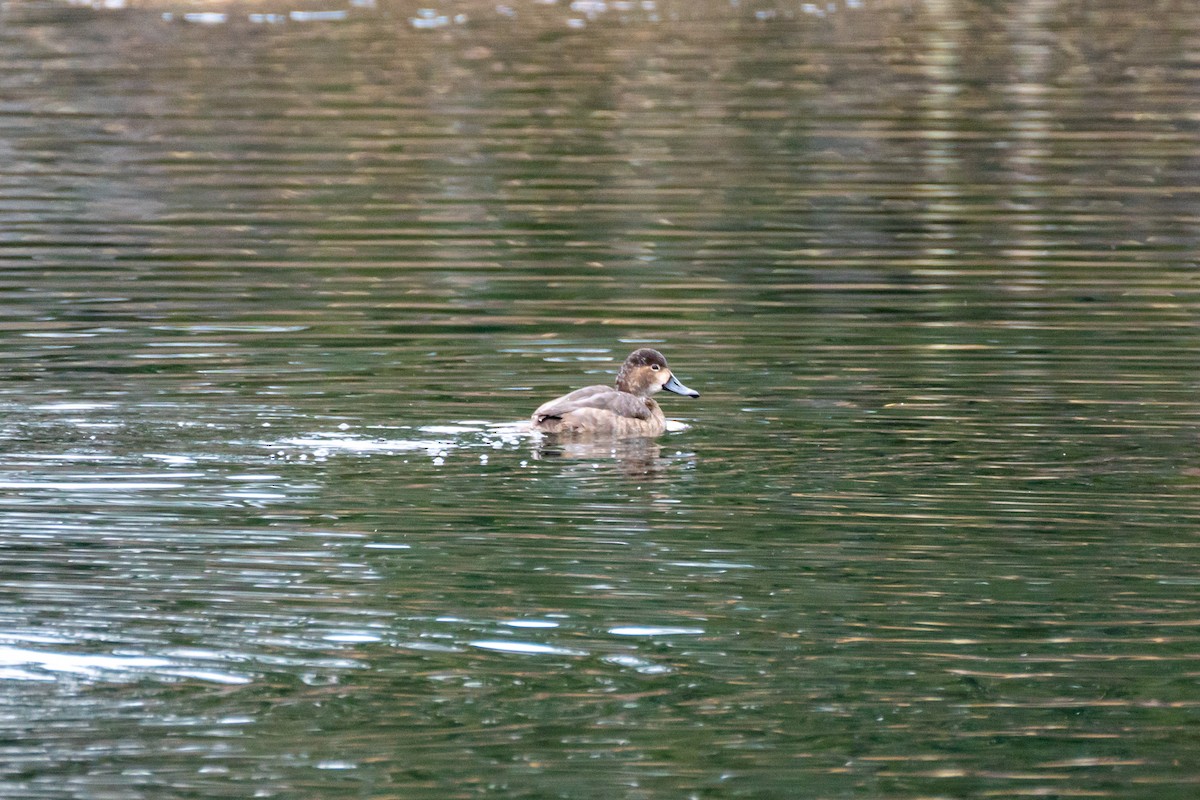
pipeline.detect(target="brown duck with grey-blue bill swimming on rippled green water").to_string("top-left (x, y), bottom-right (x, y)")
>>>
top-left (533, 348), bottom-right (700, 437)
